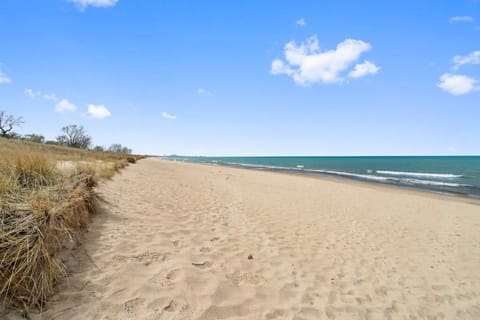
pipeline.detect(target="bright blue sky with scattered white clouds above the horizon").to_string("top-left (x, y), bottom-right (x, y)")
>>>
top-left (0, 0), bottom-right (480, 156)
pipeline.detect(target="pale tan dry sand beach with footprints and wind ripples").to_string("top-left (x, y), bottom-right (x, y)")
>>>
top-left (27, 159), bottom-right (480, 320)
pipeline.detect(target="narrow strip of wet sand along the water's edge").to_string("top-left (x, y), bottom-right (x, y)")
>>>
top-left (163, 157), bottom-right (480, 206)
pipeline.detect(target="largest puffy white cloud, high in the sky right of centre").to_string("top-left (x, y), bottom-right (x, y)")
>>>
top-left (271, 36), bottom-right (379, 85)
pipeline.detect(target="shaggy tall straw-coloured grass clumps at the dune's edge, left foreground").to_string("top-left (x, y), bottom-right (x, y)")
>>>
top-left (0, 160), bottom-right (96, 310)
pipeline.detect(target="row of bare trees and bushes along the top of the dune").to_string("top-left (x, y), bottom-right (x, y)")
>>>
top-left (0, 110), bottom-right (132, 153)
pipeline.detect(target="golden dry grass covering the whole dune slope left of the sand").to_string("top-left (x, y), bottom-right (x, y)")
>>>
top-left (0, 139), bottom-right (140, 312)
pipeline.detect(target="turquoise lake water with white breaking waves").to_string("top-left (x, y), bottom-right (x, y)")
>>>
top-left (164, 156), bottom-right (480, 197)
